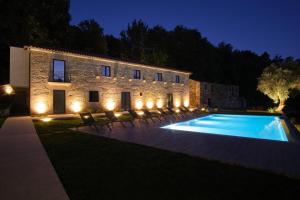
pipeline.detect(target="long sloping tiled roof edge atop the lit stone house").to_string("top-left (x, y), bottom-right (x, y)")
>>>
top-left (24, 46), bottom-right (192, 75)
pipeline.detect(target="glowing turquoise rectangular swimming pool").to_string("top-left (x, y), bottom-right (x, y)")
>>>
top-left (161, 114), bottom-right (288, 141)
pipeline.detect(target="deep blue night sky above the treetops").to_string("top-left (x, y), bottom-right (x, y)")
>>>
top-left (71, 0), bottom-right (300, 58)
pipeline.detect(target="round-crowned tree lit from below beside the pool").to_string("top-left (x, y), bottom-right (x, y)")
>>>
top-left (257, 61), bottom-right (300, 112)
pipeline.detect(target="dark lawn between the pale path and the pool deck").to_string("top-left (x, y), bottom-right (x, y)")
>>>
top-left (35, 120), bottom-right (300, 200)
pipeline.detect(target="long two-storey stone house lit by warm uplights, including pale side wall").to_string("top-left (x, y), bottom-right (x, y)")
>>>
top-left (10, 46), bottom-right (190, 114)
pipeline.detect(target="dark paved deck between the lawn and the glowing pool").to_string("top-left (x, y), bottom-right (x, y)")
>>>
top-left (79, 115), bottom-right (300, 178)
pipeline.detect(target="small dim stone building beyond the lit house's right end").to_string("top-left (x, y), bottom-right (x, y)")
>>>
top-left (189, 80), bottom-right (245, 109)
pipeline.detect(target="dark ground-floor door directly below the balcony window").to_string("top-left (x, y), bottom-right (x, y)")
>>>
top-left (53, 90), bottom-right (66, 114)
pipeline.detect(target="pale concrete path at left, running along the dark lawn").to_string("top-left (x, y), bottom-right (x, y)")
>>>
top-left (0, 117), bottom-right (69, 200)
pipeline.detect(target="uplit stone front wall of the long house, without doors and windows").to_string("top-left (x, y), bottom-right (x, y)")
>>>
top-left (25, 47), bottom-right (190, 114)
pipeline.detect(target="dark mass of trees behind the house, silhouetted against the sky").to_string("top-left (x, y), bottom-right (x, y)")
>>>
top-left (0, 0), bottom-right (300, 106)
